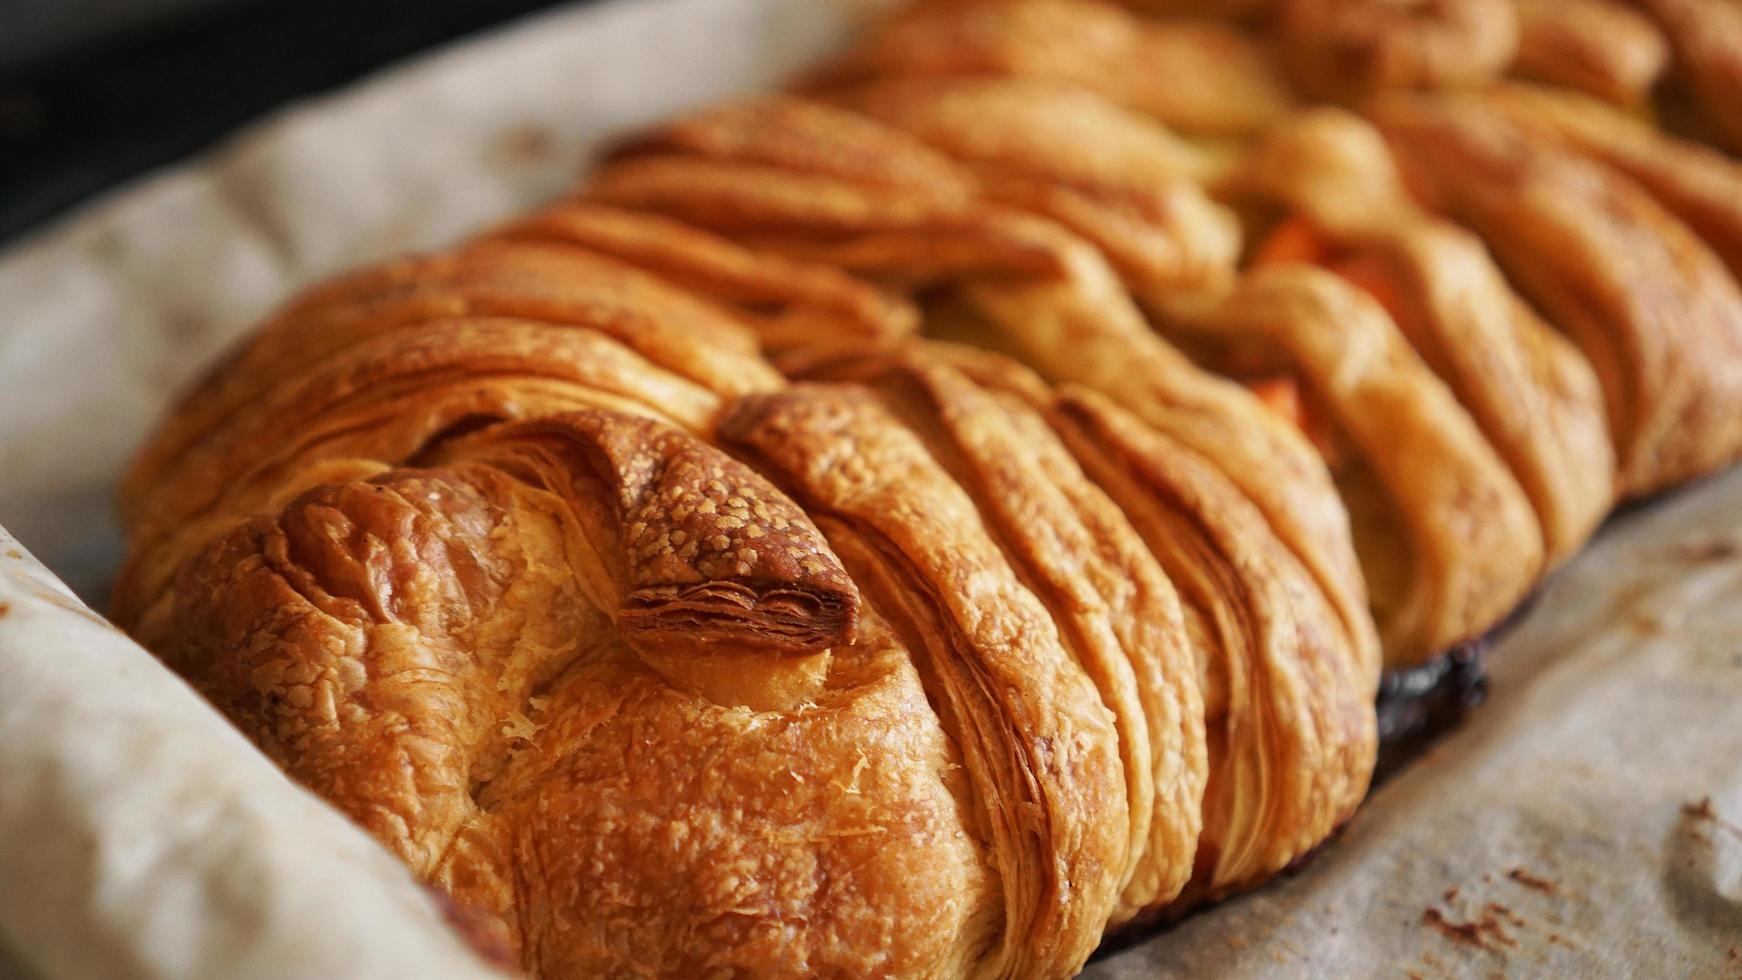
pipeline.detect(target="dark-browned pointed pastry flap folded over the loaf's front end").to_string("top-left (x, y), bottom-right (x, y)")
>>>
top-left (430, 413), bottom-right (859, 661)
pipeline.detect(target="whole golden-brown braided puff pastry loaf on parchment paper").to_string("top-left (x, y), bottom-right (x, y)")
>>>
top-left (115, 0), bottom-right (1742, 977)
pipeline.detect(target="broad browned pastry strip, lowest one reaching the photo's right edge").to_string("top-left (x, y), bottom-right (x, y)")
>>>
top-left (1374, 96), bottom-right (1742, 496)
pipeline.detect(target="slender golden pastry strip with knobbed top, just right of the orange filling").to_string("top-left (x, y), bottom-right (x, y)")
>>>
top-left (1233, 110), bottom-right (1615, 564)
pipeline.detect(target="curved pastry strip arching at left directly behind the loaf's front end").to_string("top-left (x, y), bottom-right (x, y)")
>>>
top-left (115, 319), bottom-right (766, 628)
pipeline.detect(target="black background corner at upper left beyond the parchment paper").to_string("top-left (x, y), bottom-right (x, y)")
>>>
top-left (0, 0), bottom-right (573, 242)
